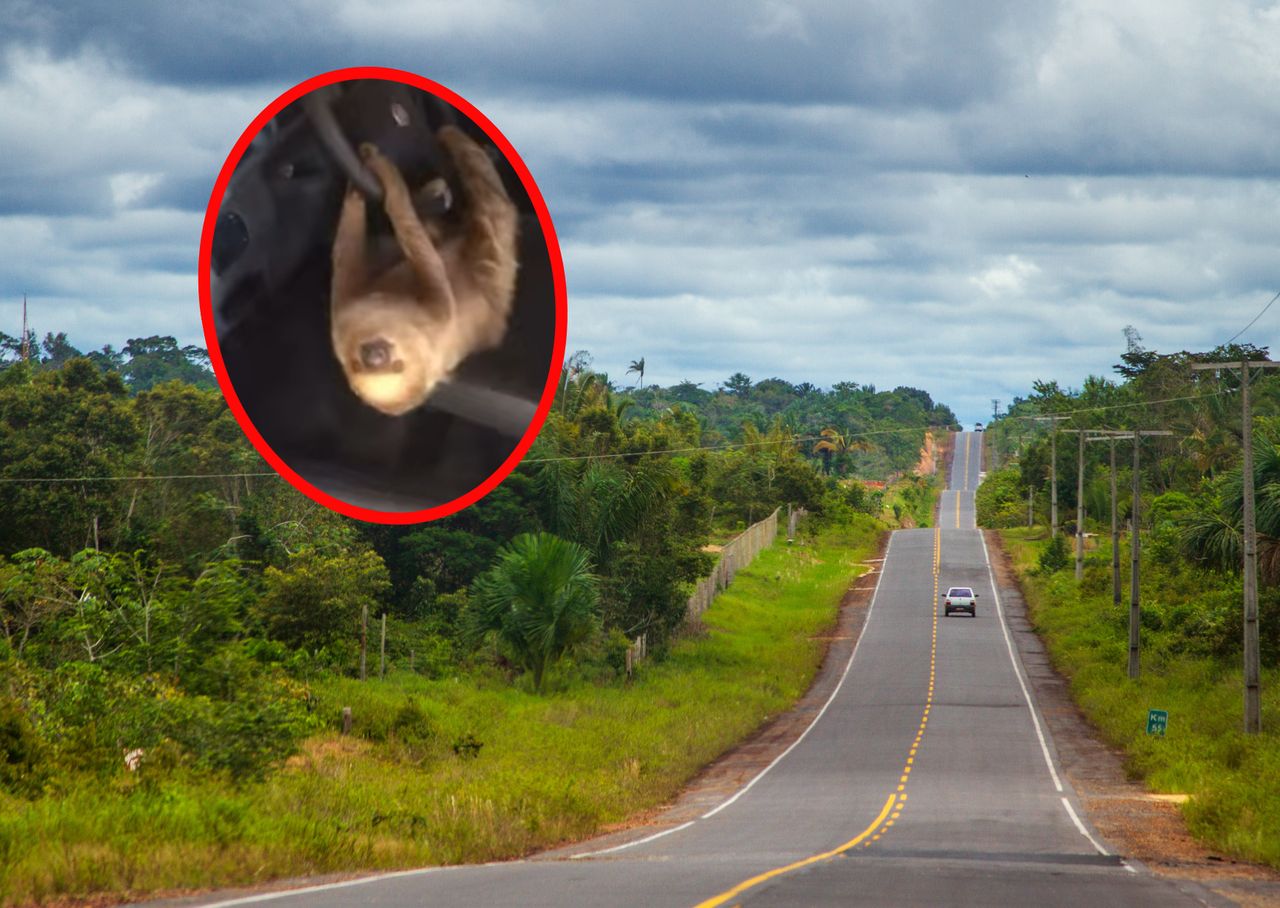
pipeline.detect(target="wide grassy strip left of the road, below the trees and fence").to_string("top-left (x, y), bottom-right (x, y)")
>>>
top-left (0, 519), bottom-right (879, 904)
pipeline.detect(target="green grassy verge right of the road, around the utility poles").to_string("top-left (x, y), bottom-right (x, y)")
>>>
top-left (1001, 529), bottom-right (1280, 868)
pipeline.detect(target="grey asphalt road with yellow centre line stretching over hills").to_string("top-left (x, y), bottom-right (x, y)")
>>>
top-left (175, 433), bottom-right (1222, 908)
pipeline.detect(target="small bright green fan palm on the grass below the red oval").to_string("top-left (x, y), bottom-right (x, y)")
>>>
top-left (467, 533), bottom-right (599, 693)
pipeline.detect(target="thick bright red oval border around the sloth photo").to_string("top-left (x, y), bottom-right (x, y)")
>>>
top-left (198, 67), bottom-right (568, 524)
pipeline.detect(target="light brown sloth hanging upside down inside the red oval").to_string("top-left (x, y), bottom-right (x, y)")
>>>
top-left (330, 127), bottom-right (518, 416)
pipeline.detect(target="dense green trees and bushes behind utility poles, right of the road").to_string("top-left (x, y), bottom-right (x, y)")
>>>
top-left (978, 328), bottom-right (1280, 665)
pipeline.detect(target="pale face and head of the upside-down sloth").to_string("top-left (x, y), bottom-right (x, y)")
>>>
top-left (333, 296), bottom-right (444, 416)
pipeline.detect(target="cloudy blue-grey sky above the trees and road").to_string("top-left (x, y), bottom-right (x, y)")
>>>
top-left (0, 0), bottom-right (1280, 423)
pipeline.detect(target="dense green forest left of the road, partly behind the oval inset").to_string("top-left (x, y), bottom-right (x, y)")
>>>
top-left (0, 334), bottom-right (951, 791)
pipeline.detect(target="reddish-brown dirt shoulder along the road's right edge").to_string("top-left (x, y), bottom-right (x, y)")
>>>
top-left (983, 530), bottom-right (1280, 905)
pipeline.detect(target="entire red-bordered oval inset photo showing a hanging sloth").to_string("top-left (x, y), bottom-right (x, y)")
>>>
top-left (200, 68), bottom-right (567, 523)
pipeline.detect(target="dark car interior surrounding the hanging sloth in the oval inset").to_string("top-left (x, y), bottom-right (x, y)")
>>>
top-left (210, 79), bottom-right (556, 512)
